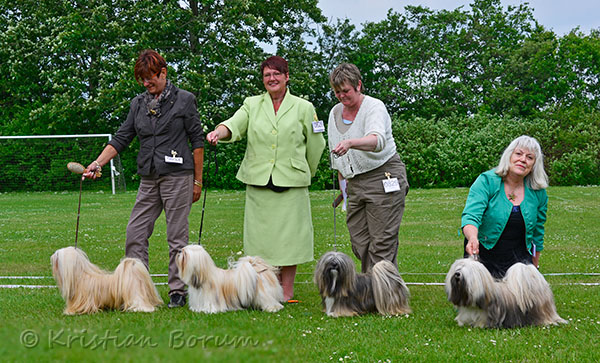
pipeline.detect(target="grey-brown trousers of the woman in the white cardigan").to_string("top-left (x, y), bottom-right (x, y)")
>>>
top-left (346, 154), bottom-right (409, 273)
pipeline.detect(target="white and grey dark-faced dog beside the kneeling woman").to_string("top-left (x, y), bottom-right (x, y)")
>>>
top-left (445, 258), bottom-right (567, 328)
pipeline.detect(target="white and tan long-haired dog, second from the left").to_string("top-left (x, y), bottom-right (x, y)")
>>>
top-left (176, 245), bottom-right (284, 313)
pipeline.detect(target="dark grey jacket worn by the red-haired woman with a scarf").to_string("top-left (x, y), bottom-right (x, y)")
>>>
top-left (109, 86), bottom-right (204, 176)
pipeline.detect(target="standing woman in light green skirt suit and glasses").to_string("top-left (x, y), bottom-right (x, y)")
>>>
top-left (206, 56), bottom-right (325, 300)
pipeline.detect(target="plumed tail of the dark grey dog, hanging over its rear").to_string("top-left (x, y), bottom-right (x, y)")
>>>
top-left (373, 260), bottom-right (412, 315)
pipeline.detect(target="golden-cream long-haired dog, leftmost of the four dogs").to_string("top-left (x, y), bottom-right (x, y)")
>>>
top-left (50, 247), bottom-right (163, 315)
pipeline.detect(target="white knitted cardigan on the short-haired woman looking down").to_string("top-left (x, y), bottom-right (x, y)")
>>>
top-left (327, 95), bottom-right (397, 179)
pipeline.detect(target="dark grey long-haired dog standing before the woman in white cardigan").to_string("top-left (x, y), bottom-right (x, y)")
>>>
top-left (314, 252), bottom-right (411, 317)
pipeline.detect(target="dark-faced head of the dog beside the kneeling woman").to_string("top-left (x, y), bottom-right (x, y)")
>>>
top-left (445, 258), bottom-right (496, 308)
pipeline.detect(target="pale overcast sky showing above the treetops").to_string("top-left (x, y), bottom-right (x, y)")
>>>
top-left (319, 0), bottom-right (600, 35)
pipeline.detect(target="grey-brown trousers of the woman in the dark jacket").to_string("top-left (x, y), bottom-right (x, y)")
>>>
top-left (125, 174), bottom-right (194, 295)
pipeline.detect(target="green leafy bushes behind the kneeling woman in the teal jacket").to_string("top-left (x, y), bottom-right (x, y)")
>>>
top-left (392, 115), bottom-right (600, 187)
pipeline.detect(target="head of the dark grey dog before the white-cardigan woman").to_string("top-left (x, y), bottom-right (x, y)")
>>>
top-left (314, 252), bottom-right (356, 297)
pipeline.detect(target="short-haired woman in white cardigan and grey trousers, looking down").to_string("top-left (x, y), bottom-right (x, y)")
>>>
top-left (328, 63), bottom-right (409, 272)
